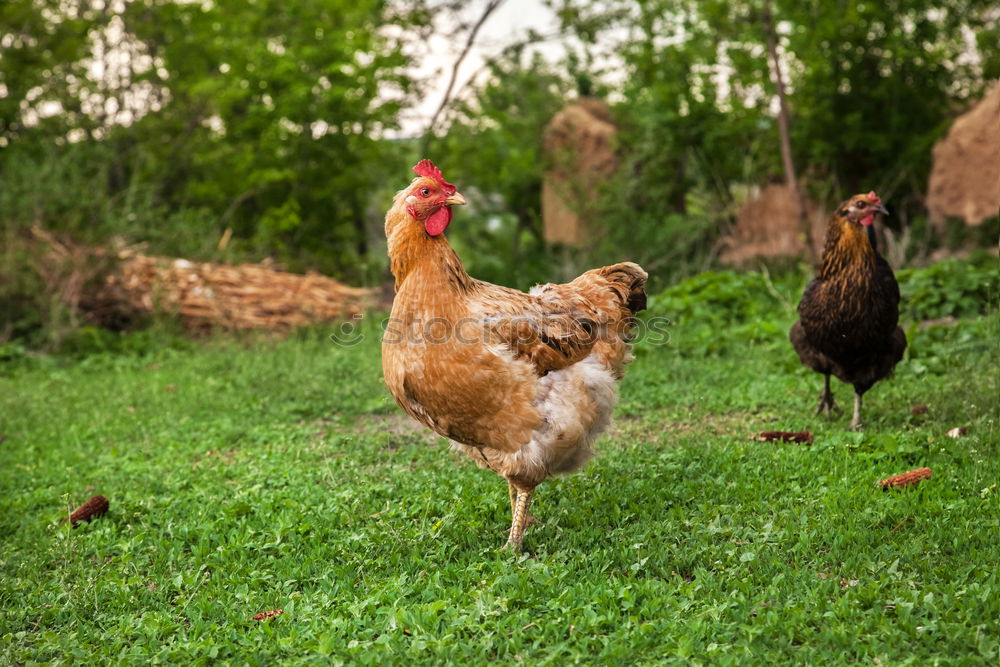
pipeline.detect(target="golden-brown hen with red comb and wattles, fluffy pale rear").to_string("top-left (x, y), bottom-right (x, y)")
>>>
top-left (382, 160), bottom-right (646, 551)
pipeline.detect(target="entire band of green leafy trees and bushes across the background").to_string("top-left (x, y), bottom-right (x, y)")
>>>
top-left (0, 0), bottom-right (1000, 338)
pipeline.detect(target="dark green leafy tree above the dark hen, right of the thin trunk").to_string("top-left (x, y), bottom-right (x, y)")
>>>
top-left (776, 0), bottom-right (1000, 215)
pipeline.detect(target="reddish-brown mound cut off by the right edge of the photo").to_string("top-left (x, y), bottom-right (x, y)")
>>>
top-left (927, 84), bottom-right (1000, 228)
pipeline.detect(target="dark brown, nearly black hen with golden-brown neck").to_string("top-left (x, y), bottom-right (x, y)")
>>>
top-left (790, 192), bottom-right (906, 428)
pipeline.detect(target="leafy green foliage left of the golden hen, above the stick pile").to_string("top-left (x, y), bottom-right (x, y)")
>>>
top-left (0, 0), bottom-right (420, 279)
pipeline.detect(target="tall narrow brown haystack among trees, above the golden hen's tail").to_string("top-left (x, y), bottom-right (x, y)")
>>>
top-left (542, 97), bottom-right (618, 246)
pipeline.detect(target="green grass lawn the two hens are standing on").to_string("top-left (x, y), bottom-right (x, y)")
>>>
top-left (0, 276), bottom-right (1000, 665)
